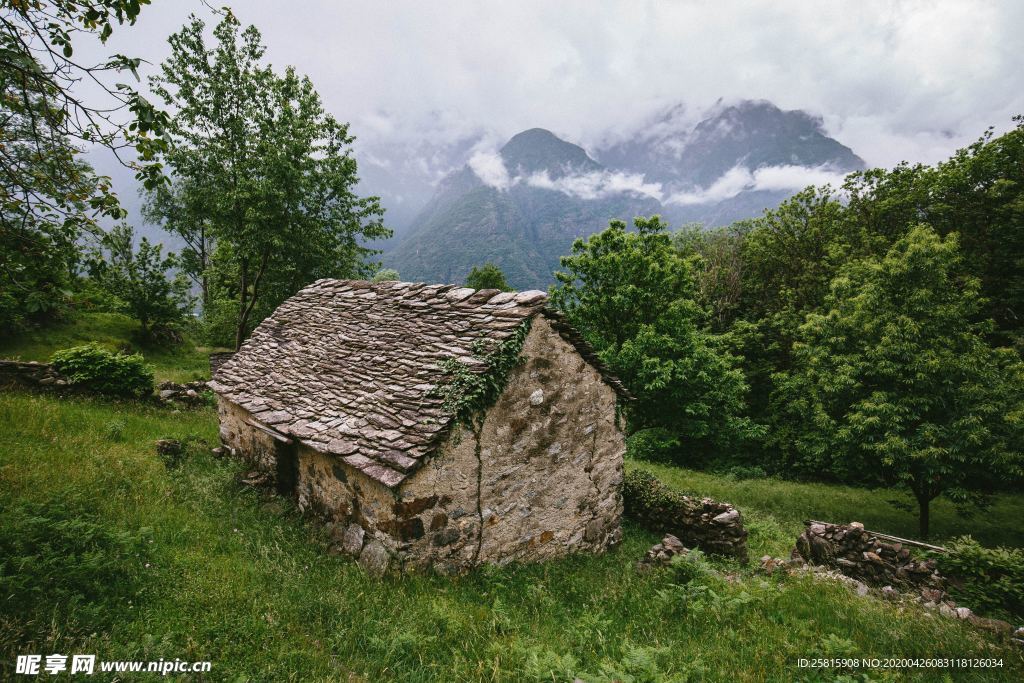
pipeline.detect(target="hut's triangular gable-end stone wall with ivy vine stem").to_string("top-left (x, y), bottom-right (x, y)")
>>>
top-left (389, 316), bottom-right (626, 571)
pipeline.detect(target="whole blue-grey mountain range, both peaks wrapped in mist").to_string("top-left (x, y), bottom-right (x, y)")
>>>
top-left (374, 101), bottom-right (864, 289)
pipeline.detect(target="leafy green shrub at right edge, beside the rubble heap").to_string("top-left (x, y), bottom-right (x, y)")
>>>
top-left (939, 536), bottom-right (1024, 620)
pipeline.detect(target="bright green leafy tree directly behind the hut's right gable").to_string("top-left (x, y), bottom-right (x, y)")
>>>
top-left (552, 216), bottom-right (758, 452)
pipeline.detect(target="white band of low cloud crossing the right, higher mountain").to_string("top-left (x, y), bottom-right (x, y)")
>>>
top-left (665, 166), bottom-right (846, 206)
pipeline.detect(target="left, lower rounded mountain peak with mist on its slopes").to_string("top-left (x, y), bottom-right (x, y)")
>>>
top-left (385, 128), bottom-right (659, 289)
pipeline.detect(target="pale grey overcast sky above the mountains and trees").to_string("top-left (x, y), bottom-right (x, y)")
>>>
top-left (83, 0), bottom-right (1024, 222)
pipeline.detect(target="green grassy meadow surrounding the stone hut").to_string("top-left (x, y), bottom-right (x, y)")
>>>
top-left (0, 317), bottom-right (1024, 681)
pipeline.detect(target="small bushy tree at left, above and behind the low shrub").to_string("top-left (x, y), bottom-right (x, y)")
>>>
top-left (90, 225), bottom-right (195, 337)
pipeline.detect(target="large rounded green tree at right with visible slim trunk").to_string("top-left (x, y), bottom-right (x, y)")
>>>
top-left (773, 225), bottom-right (1024, 538)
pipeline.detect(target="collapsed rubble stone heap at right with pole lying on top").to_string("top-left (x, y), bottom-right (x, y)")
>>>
top-left (795, 522), bottom-right (945, 590)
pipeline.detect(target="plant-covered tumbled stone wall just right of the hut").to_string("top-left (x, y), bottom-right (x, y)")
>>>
top-left (623, 470), bottom-right (748, 563)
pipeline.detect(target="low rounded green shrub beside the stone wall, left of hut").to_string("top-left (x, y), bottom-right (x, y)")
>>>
top-left (50, 344), bottom-right (153, 398)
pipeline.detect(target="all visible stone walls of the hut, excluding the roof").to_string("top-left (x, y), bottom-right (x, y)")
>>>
top-left (219, 318), bottom-right (625, 572)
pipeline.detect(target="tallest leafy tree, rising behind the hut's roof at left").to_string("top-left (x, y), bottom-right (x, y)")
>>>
top-left (154, 11), bottom-right (390, 348)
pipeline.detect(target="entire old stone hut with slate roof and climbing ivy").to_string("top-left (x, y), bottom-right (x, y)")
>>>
top-left (210, 280), bottom-right (629, 572)
